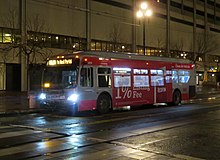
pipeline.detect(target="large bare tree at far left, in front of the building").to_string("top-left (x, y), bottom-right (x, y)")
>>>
top-left (0, 10), bottom-right (50, 91)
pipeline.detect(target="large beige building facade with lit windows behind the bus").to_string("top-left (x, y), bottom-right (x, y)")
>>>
top-left (0, 0), bottom-right (220, 91)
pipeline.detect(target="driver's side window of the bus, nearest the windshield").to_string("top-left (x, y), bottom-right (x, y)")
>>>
top-left (80, 68), bottom-right (93, 87)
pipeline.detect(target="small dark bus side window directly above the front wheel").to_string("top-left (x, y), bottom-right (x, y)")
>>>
top-left (98, 68), bottom-right (111, 87)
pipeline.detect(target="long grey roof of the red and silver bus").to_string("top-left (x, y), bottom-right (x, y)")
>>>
top-left (52, 51), bottom-right (192, 63)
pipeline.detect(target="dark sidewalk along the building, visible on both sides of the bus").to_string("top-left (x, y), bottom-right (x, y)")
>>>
top-left (0, 86), bottom-right (220, 116)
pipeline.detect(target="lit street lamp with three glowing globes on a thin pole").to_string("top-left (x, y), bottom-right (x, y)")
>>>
top-left (136, 2), bottom-right (152, 55)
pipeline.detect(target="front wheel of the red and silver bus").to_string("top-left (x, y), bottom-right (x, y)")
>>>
top-left (97, 94), bottom-right (111, 114)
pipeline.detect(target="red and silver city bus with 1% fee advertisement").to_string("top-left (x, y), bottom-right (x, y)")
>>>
top-left (38, 51), bottom-right (196, 113)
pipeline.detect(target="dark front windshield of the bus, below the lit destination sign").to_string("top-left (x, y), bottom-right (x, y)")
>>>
top-left (43, 67), bottom-right (78, 89)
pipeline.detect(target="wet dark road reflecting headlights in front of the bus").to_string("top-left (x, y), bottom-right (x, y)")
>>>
top-left (0, 99), bottom-right (220, 160)
